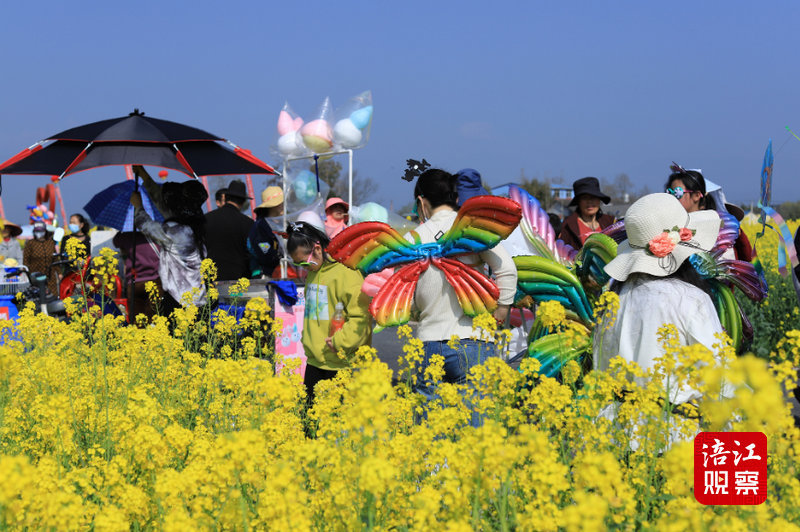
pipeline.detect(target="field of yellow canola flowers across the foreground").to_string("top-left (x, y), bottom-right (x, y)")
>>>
top-left (0, 247), bottom-right (800, 531)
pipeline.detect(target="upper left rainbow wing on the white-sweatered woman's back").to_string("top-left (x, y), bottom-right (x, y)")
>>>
top-left (327, 222), bottom-right (426, 275)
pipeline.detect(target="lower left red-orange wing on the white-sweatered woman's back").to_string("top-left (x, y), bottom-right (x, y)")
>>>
top-left (369, 260), bottom-right (430, 327)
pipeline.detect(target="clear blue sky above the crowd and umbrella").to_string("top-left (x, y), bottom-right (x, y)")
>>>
top-left (0, 0), bottom-right (800, 222)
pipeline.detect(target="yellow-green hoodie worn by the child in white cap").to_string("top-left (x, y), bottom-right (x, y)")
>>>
top-left (303, 260), bottom-right (372, 370)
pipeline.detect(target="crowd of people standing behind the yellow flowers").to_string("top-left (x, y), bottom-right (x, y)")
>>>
top-left (0, 165), bottom-right (772, 432)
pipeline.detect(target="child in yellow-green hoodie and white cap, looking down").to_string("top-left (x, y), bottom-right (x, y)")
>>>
top-left (286, 222), bottom-right (372, 404)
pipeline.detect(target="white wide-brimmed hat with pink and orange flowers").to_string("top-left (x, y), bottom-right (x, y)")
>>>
top-left (605, 193), bottom-right (720, 281)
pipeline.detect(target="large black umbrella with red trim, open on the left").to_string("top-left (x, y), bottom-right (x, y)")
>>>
top-left (0, 109), bottom-right (277, 179)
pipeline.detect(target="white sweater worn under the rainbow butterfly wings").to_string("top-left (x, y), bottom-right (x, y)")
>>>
top-left (405, 210), bottom-right (517, 342)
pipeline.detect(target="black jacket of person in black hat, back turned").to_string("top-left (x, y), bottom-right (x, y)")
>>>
top-left (206, 203), bottom-right (253, 281)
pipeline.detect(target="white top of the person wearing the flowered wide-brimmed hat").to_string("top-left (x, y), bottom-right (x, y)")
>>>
top-left (594, 276), bottom-right (722, 404)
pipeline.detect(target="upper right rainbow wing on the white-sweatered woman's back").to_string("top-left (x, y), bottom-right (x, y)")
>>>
top-left (438, 196), bottom-right (522, 257)
